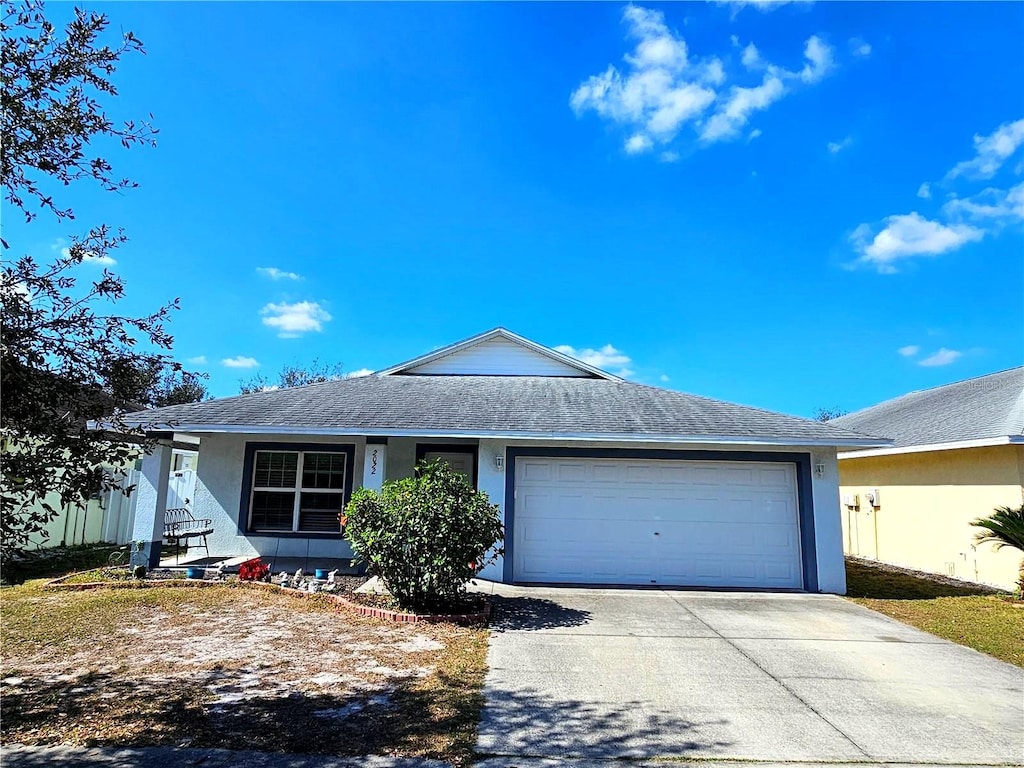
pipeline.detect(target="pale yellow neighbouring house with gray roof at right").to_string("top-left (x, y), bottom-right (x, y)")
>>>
top-left (828, 367), bottom-right (1024, 589)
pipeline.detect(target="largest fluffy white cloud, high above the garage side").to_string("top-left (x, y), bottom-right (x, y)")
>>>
top-left (569, 4), bottom-right (833, 155)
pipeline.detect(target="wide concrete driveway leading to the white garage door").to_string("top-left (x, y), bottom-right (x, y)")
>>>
top-left (477, 585), bottom-right (1024, 768)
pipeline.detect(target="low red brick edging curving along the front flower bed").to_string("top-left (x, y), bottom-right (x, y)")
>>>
top-left (43, 573), bottom-right (492, 627)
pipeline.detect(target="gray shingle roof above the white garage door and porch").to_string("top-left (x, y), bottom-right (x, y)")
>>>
top-left (119, 376), bottom-right (880, 444)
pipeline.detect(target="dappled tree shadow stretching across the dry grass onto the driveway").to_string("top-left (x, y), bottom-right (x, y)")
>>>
top-left (3, 668), bottom-right (726, 767)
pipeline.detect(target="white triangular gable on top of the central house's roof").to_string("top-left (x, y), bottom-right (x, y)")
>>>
top-left (380, 328), bottom-right (622, 381)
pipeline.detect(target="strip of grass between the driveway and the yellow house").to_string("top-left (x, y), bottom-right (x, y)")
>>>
top-left (846, 559), bottom-right (1024, 667)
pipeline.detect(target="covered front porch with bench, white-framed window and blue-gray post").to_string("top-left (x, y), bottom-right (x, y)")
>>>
top-left (132, 432), bottom-right (505, 573)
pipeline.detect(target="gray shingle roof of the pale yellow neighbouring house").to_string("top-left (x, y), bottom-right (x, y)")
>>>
top-left (828, 367), bottom-right (1024, 447)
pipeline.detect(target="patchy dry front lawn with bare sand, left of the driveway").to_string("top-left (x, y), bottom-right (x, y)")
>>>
top-left (0, 583), bottom-right (487, 763)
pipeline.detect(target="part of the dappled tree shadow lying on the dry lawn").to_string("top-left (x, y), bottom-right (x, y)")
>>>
top-left (2, 667), bottom-right (482, 765)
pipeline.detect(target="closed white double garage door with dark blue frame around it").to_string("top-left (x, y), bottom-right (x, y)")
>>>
top-left (513, 457), bottom-right (803, 589)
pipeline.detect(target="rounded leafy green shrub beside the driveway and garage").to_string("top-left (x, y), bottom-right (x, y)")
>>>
top-left (343, 462), bottom-right (504, 610)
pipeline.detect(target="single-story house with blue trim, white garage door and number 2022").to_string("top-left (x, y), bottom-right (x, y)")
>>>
top-left (116, 328), bottom-right (887, 593)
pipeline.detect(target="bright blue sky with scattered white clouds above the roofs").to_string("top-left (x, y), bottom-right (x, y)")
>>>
top-left (4, 2), bottom-right (1024, 415)
